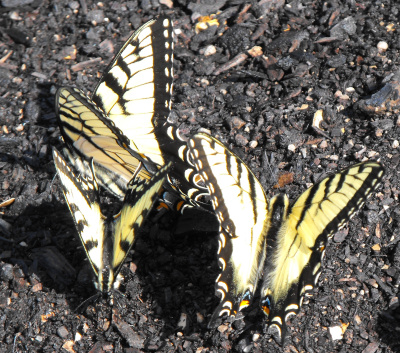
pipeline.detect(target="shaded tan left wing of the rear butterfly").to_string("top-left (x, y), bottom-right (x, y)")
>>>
top-left (56, 87), bottom-right (156, 198)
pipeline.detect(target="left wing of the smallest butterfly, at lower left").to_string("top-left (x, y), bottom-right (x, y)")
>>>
top-left (53, 149), bottom-right (105, 282)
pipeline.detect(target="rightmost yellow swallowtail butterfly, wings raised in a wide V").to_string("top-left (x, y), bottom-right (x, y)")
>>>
top-left (189, 134), bottom-right (384, 341)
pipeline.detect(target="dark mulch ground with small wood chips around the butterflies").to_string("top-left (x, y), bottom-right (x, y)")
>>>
top-left (0, 0), bottom-right (400, 353)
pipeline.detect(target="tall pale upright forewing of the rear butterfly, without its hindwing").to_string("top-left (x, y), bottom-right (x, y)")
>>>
top-left (92, 17), bottom-right (173, 165)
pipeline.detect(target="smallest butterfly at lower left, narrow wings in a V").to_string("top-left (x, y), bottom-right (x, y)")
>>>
top-left (53, 149), bottom-right (170, 292)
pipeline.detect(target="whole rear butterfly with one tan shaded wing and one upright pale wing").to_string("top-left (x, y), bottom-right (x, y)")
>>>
top-left (56, 17), bottom-right (207, 211)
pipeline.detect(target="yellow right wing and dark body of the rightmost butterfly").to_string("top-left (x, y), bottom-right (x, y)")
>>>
top-left (261, 161), bottom-right (384, 340)
